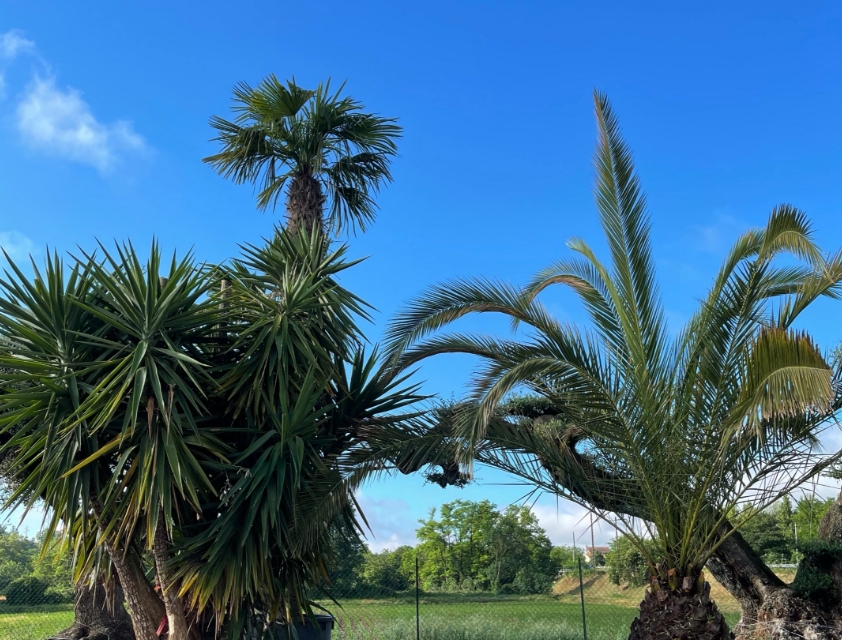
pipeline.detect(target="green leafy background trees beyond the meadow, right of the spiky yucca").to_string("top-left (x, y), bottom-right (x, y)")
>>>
top-left (331, 496), bottom-right (834, 597)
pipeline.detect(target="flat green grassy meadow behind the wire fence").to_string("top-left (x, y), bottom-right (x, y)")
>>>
top-left (0, 569), bottom-right (794, 640)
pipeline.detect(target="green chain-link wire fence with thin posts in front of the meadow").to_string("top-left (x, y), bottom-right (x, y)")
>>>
top-left (0, 561), bottom-right (780, 640)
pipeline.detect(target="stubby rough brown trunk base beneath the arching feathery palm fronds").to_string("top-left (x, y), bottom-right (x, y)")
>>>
top-left (629, 583), bottom-right (734, 640)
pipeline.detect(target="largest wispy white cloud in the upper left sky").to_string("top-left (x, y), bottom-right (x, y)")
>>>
top-left (17, 78), bottom-right (146, 172)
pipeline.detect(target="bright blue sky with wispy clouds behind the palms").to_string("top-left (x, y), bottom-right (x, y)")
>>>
top-left (0, 0), bottom-right (842, 548)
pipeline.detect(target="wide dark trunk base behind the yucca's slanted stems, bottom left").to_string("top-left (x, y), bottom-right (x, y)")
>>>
top-left (49, 582), bottom-right (135, 640)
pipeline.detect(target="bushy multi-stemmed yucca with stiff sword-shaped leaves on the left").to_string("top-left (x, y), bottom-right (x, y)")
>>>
top-left (0, 231), bottom-right (419, 640)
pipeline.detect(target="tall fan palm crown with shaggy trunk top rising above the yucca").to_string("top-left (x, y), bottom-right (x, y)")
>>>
top-left (205, 75), bottom-right (401, 233)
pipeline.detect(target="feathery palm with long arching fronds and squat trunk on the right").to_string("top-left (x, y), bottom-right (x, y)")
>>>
top-left (389, 93), bottom-right (842, 639)
